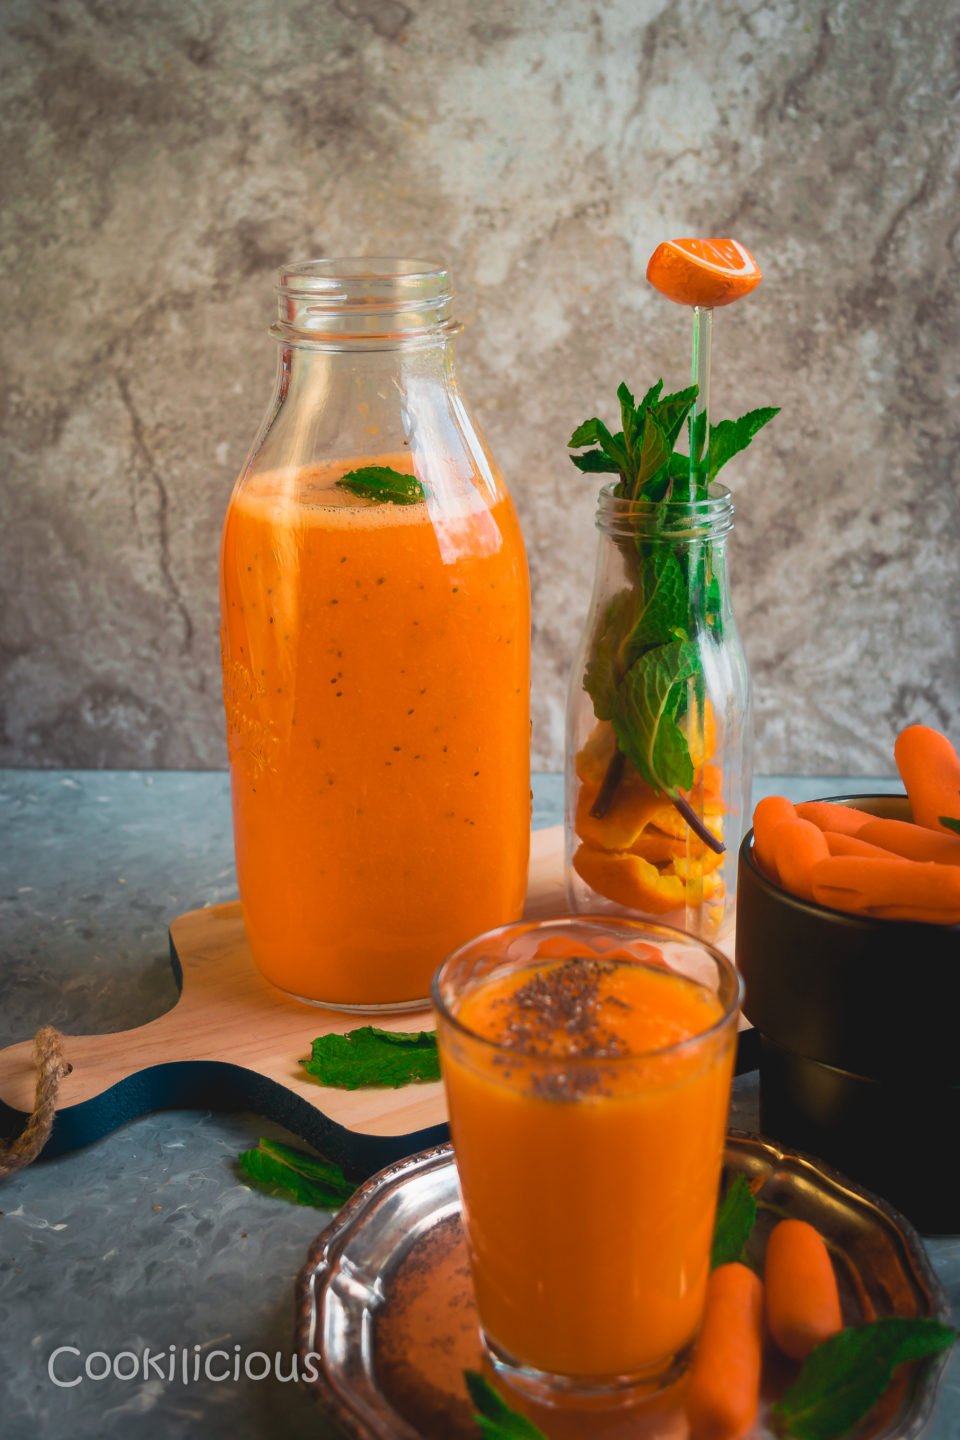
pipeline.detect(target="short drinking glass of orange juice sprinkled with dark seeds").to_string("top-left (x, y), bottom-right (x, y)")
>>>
top-left (433, 917), bottom-right (740, 1398)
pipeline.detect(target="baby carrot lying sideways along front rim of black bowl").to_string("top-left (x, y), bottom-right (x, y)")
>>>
top-left (812, 855), bottom-right (960, 924)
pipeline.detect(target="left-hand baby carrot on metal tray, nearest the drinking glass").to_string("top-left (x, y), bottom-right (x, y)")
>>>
top-left (687, 1261), bottom-right (763, 1440)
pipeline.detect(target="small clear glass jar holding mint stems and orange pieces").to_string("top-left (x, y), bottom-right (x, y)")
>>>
top-left (566, 484), bottom-right (751, 940)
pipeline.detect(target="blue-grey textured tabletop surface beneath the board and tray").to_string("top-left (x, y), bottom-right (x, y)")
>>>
top-left (0, 772), bottom-right (960, 1440)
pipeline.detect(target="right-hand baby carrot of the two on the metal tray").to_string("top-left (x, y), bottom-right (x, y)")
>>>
top-left (764, 1220), bottom-right (843, 1359)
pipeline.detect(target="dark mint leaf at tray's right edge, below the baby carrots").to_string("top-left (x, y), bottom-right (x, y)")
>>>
top-left (770, 1316), bottom-right (957, 1440)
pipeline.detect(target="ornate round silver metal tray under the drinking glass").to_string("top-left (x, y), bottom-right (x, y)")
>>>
top-left (296, 1130), bottom-right (948, 1440)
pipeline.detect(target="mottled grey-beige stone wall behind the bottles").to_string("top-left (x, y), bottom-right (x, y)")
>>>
top-left (0, 0), bottom-right (960, 773)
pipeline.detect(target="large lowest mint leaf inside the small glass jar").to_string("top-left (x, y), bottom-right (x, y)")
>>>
top-left (612, 639), bottom-right (699, 799)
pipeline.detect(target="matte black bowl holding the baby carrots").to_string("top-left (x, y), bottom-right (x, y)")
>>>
top-left (737, 795), bottom-right (960, 1234)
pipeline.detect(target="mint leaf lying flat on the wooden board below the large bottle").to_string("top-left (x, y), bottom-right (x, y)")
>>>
top-left (301, 1025), bottom-right (440, 1090)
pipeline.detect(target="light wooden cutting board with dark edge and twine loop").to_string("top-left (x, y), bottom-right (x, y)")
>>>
top-left (0, 825), bottom-right (748, 1175)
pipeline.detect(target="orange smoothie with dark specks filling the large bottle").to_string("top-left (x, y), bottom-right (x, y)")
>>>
top-left (222, 452), bottom-right (530, 1008)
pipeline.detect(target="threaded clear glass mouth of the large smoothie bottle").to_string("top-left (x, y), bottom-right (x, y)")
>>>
top-left (271, 256), bottom-right (459, 348)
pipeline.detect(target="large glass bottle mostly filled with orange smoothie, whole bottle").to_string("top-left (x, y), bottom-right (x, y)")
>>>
top-left (220, 259), bottom-right (530, 1009)
